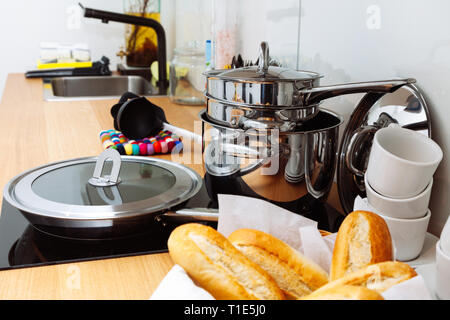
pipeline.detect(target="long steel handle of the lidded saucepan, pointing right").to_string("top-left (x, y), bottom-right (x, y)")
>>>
top-left (300, 78), bottom-right (416, 105)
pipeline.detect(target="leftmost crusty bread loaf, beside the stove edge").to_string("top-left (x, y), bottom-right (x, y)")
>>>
top-left (168, 223), bottom-right (284, 300)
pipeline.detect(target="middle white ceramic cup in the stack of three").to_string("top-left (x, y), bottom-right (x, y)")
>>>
top-left (364, 174), bottom-right (433, 219)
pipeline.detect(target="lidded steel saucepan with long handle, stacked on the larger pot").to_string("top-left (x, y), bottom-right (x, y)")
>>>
top-left (205, 42), bottom-right (415, 131)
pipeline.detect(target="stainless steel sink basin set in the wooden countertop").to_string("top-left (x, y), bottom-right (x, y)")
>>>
top-left (44, 76), bottom-right (158, 101)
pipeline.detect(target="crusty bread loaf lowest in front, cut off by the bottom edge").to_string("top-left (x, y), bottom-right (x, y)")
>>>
top-left (300, 285), bottom-right (384, 300)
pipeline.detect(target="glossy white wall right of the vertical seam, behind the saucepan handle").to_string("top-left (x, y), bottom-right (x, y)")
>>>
top-left (299, 0), bottom-right (450, 235)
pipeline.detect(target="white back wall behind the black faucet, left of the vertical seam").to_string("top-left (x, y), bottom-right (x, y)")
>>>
top-left (0, 0), bottom-right (299, 96)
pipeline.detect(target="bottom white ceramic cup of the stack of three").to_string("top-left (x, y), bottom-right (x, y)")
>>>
top-left (377, 210), bottom-right (431, 261)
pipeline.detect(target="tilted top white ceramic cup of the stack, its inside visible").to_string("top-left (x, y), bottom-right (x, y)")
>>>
top-left (366, 126), bottom-right (443, 198)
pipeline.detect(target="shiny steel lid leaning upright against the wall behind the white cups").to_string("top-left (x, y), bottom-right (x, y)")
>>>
top-left (337, 84), bottom-right (431, 213)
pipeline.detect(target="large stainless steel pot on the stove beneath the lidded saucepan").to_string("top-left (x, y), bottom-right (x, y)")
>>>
top-left (200, 110), bottom-right (343, 202)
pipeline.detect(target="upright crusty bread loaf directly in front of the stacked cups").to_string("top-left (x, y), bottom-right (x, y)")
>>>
top-left (330, 211), bottom-right (393, 281)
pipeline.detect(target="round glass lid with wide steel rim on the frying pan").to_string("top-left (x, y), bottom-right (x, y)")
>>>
top-left (4, 149), bottom-right (202, 220)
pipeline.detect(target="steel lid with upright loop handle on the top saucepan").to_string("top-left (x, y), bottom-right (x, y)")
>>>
top-left (205, 41), bottom-right (322, 82)
